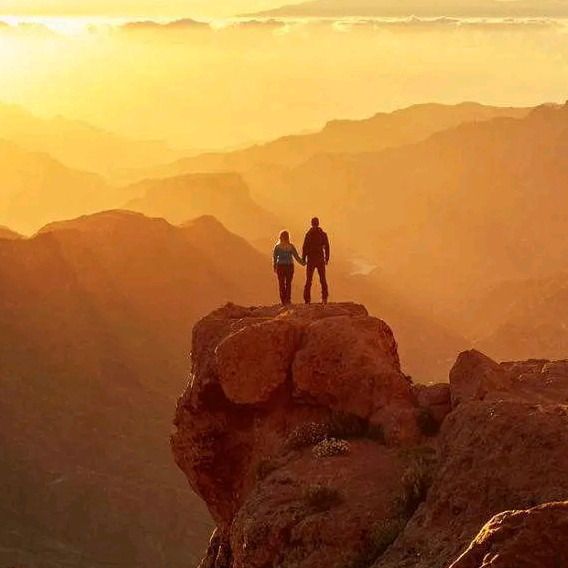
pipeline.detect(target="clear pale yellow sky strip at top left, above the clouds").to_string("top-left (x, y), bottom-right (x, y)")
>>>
top-left (0, 0), bottom-right (298, 17)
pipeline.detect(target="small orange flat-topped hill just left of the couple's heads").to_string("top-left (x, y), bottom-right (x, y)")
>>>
top-left (125, 173), bottom-right (284, 242)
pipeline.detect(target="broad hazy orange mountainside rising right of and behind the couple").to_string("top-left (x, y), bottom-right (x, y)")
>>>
top-left (125, 98), bottom-right (568, 364)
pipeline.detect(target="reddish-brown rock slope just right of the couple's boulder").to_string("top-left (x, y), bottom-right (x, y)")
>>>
top-left (374, 351), bottom-right (568, 568)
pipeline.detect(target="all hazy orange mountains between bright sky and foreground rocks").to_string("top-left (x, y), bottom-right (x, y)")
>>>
top-left (5, 96), bottom-right (568, 568)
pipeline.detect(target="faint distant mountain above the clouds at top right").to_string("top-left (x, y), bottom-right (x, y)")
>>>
top-left (255, 0), bottom-right (568, 18)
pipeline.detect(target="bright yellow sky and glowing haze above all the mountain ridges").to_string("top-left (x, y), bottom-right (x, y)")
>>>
top-left (0, 0), bottom-right (568, 150)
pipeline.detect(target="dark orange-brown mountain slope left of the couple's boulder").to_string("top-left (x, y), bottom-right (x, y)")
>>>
top-left (0, 212), bottom-right (278, 568)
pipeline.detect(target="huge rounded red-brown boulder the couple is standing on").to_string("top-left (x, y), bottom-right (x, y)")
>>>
top-left (172, 304), bottom-right (425, 568)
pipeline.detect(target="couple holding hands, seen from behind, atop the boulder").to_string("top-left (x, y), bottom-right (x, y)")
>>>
top-left (273, 217), bottom-right (329, 306)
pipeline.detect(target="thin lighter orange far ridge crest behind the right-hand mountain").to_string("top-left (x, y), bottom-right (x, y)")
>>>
top-left (132, 103), bottom-right (529, 181)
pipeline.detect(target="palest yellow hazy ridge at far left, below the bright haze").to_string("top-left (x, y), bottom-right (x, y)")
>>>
top-left (0, 103), bottom-right (179, 177)
